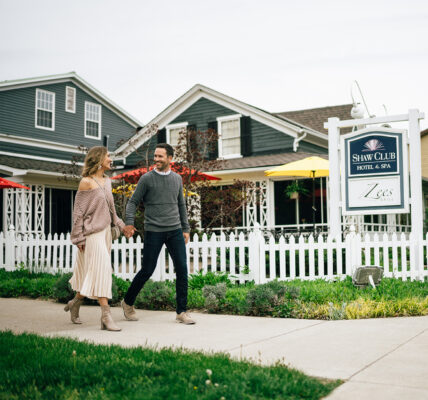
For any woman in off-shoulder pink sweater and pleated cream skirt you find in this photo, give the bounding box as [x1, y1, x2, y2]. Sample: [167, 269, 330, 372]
[64, 146, 125, 331]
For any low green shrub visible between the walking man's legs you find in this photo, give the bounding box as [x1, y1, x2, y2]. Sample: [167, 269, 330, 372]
[134, 280, 175, 310]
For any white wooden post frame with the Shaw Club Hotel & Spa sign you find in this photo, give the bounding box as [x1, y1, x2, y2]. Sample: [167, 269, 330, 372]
[324, 109, 424, 279]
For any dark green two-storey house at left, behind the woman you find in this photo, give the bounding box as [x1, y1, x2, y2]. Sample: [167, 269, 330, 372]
[0, 72, 142, 234]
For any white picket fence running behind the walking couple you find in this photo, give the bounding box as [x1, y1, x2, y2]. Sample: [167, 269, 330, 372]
[0, 229, 428, 283]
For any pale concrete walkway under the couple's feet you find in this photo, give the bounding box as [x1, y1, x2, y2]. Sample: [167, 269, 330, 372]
[0, 298, 428, 400]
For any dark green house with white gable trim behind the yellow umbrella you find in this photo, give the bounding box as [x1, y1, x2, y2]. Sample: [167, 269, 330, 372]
[115, 84, 360, 234]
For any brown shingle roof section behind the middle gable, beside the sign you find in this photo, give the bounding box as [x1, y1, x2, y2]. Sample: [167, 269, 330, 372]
[272, 104, 352, 133]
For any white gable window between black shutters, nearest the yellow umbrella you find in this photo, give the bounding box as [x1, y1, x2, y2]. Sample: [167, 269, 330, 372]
[217, 115, 241, 158]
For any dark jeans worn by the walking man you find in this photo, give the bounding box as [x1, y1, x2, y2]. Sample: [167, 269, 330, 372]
[125, 229, 187, 314]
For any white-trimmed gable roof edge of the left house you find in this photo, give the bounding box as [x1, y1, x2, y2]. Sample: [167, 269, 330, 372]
[0, 71, 143, 128]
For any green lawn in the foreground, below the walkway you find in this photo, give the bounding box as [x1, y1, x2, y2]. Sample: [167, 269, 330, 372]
[0, 332, 341, 400]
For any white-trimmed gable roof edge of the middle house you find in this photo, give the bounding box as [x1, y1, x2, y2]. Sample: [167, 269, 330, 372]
[115, 84, 327, 157]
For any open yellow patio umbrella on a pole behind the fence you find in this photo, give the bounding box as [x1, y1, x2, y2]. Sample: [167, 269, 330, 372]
[265, 156, 329, 231]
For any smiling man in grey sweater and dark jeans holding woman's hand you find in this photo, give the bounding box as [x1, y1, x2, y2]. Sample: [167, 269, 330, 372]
[122, 143, 195, 325]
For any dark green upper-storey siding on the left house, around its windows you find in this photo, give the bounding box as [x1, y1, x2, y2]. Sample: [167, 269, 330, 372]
[0, 82, 135, 150]
